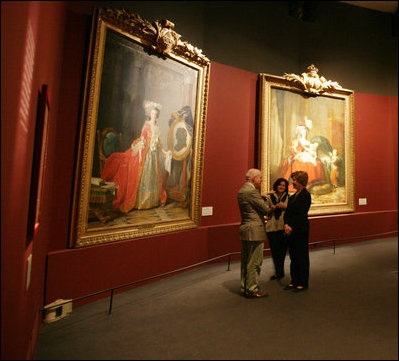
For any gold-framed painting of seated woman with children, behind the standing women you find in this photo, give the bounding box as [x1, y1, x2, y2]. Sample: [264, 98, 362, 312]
[258, 65, 355, 215]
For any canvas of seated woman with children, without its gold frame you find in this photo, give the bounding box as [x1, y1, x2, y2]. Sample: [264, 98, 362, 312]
[270, 88, 346, 204]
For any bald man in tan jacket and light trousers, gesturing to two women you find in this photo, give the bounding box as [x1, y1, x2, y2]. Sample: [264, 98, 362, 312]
[238, 168, 269, 298]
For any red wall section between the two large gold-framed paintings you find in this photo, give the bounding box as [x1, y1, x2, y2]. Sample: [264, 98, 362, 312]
[201, 62, 257, 226]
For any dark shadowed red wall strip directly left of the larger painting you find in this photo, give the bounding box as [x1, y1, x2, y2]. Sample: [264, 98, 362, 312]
[48, 2, 89, 251]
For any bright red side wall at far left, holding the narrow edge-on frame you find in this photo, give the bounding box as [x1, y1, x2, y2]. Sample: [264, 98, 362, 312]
[1, 1, 69, 359]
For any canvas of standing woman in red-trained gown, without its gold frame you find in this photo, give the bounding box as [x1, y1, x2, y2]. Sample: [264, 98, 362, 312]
[88, 31, 198, 230]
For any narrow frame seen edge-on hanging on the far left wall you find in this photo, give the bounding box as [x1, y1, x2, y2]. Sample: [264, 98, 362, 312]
[26, 84, 50, 246]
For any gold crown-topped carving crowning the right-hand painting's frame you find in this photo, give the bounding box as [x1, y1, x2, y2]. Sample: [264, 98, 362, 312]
[284, 64, 342, 95]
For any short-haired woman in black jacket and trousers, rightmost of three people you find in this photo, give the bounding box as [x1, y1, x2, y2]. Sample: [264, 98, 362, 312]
[284, 171, 312, 292]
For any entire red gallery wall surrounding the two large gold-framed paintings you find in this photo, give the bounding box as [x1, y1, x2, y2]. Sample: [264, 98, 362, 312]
[1, 1, 398, 359]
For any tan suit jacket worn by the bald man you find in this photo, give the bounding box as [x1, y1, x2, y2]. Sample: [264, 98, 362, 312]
[238, 182, 269, 241]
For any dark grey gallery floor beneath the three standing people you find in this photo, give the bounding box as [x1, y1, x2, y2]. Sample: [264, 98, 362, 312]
[35, 237, 398, 360]
